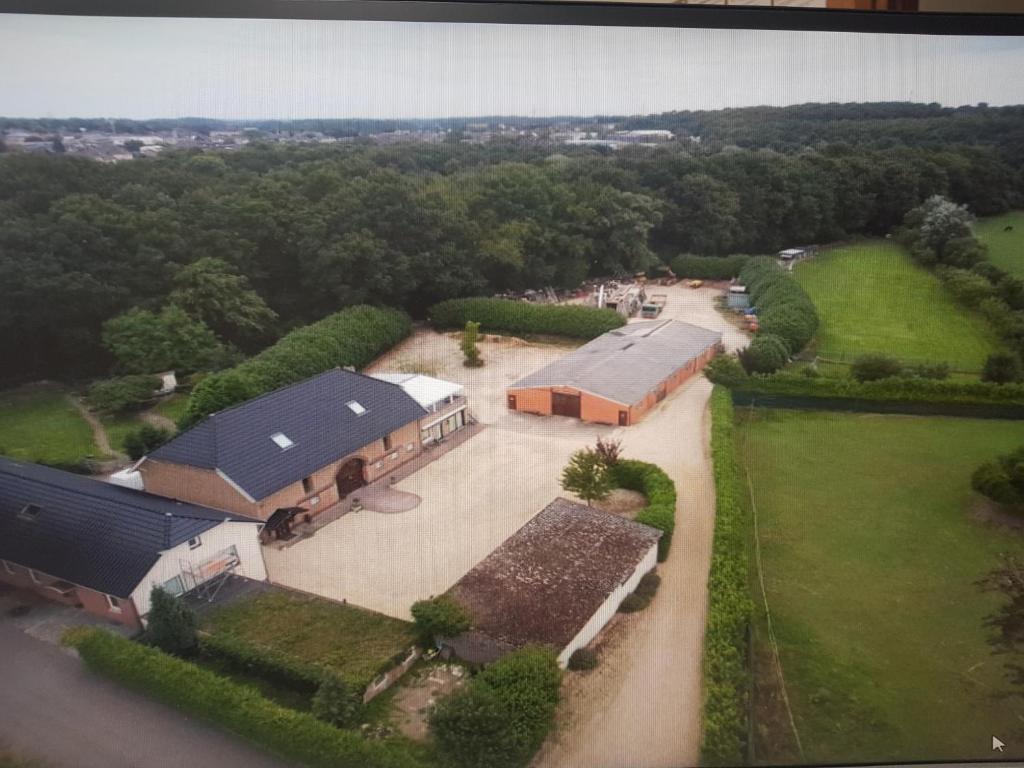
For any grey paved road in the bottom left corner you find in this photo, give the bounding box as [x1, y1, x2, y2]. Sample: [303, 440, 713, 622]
[0, 620, 286, 768]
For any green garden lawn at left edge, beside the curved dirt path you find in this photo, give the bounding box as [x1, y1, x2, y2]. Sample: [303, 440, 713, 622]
[0, 385, 98, 463]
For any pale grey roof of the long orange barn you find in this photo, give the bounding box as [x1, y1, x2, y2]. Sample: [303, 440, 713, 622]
[509, 319, 722, 406]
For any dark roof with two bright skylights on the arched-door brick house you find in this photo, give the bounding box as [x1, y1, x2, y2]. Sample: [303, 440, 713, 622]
[150, 368, 426, 501]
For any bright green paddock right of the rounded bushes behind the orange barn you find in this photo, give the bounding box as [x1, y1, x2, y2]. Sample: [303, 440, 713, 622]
[795, 241, 997, 371]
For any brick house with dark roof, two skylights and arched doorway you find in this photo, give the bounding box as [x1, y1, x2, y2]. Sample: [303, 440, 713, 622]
[137, 369, 465, 520]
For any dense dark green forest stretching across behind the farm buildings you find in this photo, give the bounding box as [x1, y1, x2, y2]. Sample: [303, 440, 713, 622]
[6, 104, 1024, 382]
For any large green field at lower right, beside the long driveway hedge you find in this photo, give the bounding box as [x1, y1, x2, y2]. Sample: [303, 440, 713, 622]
[737, 411, 1024, 763]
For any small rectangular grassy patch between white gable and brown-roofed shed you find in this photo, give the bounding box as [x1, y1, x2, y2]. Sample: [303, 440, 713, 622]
[203, 591, 415, 686]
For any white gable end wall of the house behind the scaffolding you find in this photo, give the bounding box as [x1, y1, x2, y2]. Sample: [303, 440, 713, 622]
[131, 521, 266, 616]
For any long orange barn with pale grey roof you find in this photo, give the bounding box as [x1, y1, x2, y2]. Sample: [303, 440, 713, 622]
[506, 319, 722, 427]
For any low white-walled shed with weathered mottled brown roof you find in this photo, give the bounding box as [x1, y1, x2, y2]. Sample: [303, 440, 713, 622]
[440, 499, 662, 667]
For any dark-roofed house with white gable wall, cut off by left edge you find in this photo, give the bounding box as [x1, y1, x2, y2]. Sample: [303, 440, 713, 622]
[0, 458, 266, 629]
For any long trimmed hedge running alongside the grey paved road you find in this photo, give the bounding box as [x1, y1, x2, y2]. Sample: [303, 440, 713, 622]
[67, 629, 424, 768]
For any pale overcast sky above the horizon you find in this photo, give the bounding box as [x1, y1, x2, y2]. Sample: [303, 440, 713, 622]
[0, 14, 1024, 119]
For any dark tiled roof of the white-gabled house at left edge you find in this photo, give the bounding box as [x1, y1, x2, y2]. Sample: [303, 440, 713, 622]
[0, 457, 260, 597]
